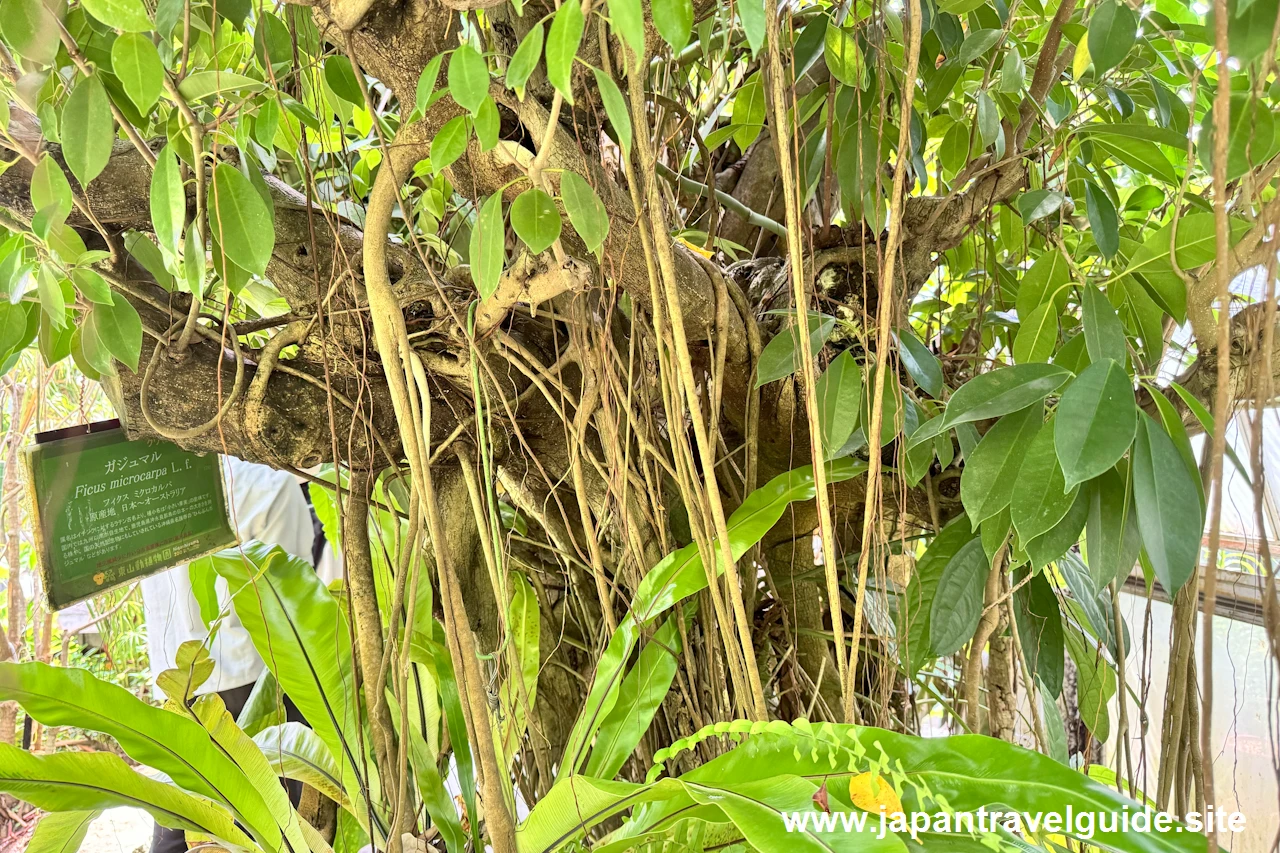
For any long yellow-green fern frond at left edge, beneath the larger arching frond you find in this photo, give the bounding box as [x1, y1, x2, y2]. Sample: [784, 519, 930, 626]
[0, 742, 253, 849]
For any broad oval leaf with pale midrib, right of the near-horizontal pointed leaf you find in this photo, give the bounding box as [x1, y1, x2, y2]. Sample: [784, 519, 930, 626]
[1053, 359, 1138, 488]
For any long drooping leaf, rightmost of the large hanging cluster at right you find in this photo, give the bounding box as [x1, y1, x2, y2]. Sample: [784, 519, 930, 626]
[1133, 412, 1204, 596]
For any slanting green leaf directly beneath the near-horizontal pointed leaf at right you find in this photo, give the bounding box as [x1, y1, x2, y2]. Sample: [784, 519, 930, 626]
[960, 403, 1044, 530]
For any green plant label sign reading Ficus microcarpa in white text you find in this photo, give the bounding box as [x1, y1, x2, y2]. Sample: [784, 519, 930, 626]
[24, 421, 237, 610]
